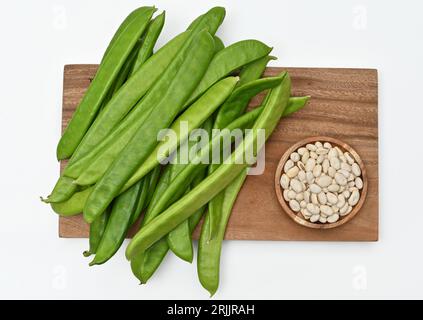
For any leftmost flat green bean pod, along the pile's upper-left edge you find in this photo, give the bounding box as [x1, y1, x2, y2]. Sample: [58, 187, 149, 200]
[57, 7, 156, 160]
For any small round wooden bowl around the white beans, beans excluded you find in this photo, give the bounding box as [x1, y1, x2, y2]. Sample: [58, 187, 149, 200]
[275, 136, 368, 229]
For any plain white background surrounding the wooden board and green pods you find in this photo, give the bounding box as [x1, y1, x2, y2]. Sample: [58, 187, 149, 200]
[0, 0, 423, 299]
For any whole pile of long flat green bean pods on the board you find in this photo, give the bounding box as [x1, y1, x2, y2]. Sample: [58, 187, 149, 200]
[42, 7, 309, 295]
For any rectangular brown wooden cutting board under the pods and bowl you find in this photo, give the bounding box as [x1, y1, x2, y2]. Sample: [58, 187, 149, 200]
[59, 65, 379, 241]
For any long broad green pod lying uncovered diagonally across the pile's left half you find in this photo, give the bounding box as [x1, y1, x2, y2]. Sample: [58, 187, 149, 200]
[84, 31, 214, 222]
